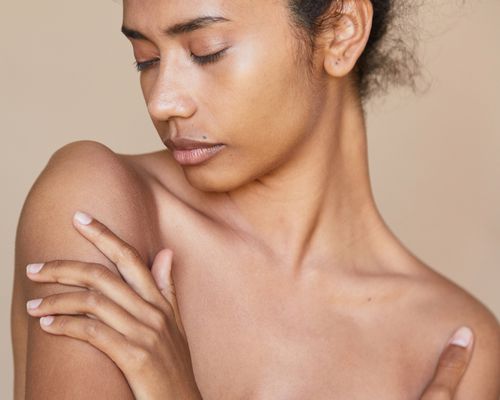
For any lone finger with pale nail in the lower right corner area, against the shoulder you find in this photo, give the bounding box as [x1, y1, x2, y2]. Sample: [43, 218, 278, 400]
[420, 327, 473, 400]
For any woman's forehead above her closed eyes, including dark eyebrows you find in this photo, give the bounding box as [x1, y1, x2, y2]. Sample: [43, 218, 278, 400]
[122, 0, 294, 48]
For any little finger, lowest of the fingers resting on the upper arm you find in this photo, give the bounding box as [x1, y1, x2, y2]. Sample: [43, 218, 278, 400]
[40, 315, 141, 373]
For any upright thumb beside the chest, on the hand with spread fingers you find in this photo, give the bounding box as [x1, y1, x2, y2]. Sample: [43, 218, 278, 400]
[151, 249, 186, 338]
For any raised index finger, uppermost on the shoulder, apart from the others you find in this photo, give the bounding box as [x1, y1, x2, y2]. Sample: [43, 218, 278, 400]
[73, 211, 163, 305]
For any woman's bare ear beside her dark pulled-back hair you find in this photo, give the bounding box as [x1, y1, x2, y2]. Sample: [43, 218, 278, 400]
[324, 0, 373, 78]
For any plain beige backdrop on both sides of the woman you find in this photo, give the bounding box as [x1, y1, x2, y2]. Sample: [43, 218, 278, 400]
[0, 0, 500, 399]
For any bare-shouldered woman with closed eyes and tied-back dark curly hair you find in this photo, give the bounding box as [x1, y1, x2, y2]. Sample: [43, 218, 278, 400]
[12, 0, 500, 400]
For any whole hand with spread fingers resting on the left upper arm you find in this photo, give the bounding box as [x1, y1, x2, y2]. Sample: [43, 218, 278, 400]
[27, 213, 201, 400]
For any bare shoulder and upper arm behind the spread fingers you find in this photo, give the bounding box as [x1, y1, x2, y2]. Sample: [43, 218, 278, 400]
[12, 141, 155, 400]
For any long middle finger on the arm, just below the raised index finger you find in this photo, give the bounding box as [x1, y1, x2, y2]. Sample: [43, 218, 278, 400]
[26, 260, 168, 326]
